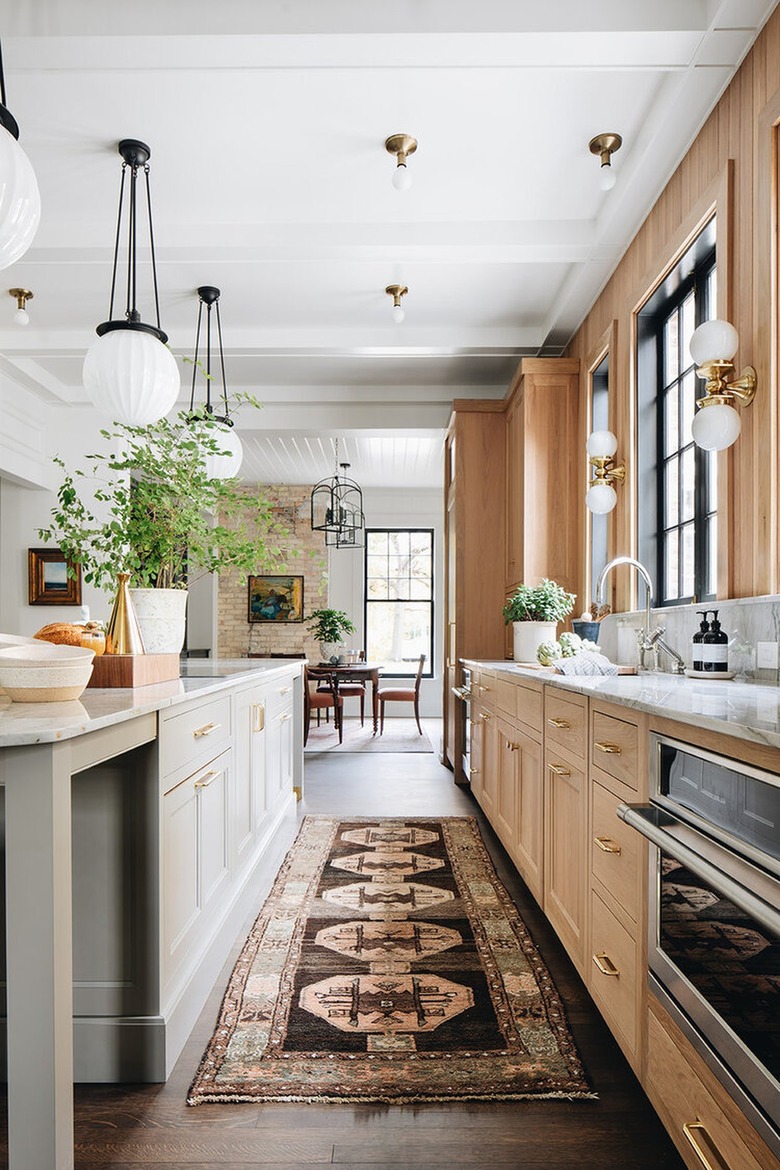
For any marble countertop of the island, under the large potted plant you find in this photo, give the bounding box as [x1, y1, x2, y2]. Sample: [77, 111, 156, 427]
[0, 659, 303, 748]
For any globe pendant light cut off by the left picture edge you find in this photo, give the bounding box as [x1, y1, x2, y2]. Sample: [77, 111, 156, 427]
[0, 41, 41, 268]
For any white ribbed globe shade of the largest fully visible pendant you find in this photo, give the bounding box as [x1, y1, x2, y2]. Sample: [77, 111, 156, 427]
[83, 329, 181, 427]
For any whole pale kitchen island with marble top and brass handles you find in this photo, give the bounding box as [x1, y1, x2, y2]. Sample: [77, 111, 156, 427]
[0, 660, 303, 1170]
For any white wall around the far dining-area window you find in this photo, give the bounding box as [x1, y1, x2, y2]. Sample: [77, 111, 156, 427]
[327, 488, 444, 718]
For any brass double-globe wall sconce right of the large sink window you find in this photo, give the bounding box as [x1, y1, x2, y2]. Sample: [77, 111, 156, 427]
[690, 321, 757, 450]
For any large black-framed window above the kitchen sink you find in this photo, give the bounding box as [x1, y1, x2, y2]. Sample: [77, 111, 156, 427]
[637, 220, 718, 606]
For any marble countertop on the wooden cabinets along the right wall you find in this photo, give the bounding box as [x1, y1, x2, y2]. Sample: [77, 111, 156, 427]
[463, 659, 780, 748]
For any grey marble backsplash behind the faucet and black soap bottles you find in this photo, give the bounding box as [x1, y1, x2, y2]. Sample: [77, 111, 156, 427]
[591, 594, 780, 684]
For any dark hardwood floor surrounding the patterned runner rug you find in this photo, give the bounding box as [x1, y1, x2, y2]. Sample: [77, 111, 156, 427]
[67, 724, 684, 1170]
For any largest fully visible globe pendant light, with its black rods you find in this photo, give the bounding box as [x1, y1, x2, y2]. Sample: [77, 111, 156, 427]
[83, 138, 180, 427]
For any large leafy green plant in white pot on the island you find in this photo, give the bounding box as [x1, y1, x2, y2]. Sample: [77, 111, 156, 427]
[39, 411, 285, 653]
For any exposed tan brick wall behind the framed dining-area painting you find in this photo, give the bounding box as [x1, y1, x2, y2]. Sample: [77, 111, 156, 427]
[214, 484, 327, 662]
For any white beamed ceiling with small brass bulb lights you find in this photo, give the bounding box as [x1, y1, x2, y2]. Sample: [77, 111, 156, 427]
[0, 0, 775, 487]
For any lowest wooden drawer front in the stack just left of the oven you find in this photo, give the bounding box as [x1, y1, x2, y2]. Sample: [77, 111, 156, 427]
[589, 893, 639, 1052]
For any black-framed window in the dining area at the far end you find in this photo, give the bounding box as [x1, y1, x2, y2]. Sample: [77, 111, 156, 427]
[365, 528, 434, 677]
